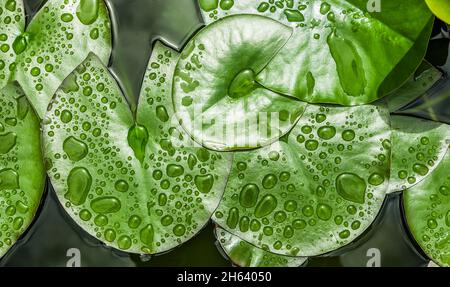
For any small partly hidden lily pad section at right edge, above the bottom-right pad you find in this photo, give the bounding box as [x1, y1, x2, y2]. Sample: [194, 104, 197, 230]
[389, 116, 450, 192]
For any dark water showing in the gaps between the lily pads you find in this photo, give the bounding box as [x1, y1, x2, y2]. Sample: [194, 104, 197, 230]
[0, 0, 445, 266]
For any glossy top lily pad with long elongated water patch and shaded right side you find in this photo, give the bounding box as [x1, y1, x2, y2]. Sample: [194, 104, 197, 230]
[199, 0, 433, 105]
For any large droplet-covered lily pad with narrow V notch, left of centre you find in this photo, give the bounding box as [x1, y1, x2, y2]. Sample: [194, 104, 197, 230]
[44, 43, 231, 254]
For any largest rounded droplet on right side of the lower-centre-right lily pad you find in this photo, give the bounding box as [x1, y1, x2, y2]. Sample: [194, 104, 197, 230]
[336, 173, 367, 204]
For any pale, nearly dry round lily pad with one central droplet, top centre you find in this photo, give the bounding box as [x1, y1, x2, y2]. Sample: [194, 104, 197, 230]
[173, 15, 306, 151]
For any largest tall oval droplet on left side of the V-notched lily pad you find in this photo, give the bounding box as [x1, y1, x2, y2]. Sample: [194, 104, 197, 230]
[64, 167, 92, 206]
